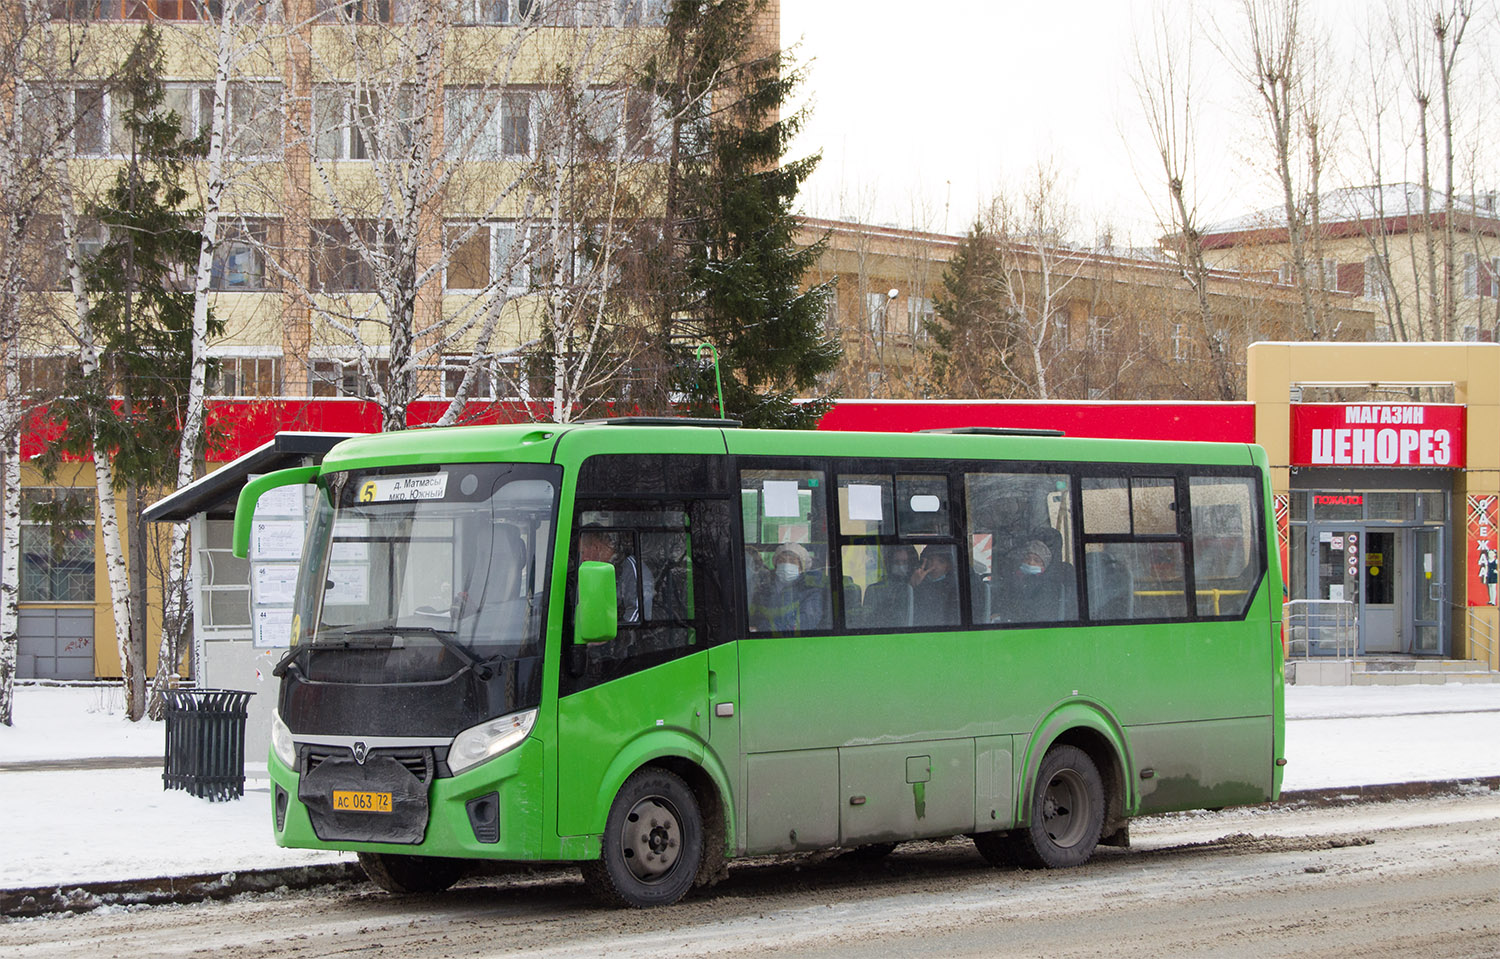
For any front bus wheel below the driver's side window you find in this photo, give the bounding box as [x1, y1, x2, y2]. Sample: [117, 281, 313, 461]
[582, 765, 704, 909]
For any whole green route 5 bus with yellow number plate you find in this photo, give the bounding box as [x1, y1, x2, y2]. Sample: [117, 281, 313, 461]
[236, 419, 1284, 906]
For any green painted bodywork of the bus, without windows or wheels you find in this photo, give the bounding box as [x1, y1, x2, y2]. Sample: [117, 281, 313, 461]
[272, 423, 1286, 858]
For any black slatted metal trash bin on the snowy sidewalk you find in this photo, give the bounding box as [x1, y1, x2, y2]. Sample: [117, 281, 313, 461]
[162, 689, 255, 803]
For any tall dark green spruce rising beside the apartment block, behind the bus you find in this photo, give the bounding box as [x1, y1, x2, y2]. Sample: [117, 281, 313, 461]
[647, 0, 840, 428]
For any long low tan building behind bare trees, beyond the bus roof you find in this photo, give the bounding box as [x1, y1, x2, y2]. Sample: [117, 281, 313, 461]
[798, 218, 1377, 399]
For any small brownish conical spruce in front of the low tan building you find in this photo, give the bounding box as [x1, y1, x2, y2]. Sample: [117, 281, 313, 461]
[927, 219, 1022, 399]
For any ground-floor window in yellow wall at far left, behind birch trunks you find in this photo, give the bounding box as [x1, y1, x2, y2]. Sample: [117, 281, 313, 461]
[20, 488, 95, 603]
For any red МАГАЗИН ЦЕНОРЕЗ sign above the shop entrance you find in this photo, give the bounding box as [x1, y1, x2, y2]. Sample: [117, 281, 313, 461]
[1292, 402, 1464, 468]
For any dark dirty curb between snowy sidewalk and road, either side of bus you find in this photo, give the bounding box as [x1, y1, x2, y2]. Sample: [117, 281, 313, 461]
[0, 776, 1500, 918]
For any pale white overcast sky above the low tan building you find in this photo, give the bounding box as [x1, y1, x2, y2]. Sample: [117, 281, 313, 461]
[782, 0, 1440, 245]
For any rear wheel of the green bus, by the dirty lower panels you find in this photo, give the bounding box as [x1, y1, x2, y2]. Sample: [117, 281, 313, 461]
[1014, 746, 1104, 869]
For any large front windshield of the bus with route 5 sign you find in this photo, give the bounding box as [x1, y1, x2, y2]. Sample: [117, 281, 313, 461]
[297, 464, 557, 683]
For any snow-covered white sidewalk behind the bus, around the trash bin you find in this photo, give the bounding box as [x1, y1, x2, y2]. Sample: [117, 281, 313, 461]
[0, 684, 1500, 888]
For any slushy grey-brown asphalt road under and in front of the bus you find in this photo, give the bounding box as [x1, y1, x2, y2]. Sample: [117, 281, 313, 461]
[0, 786, 1500, 959]
